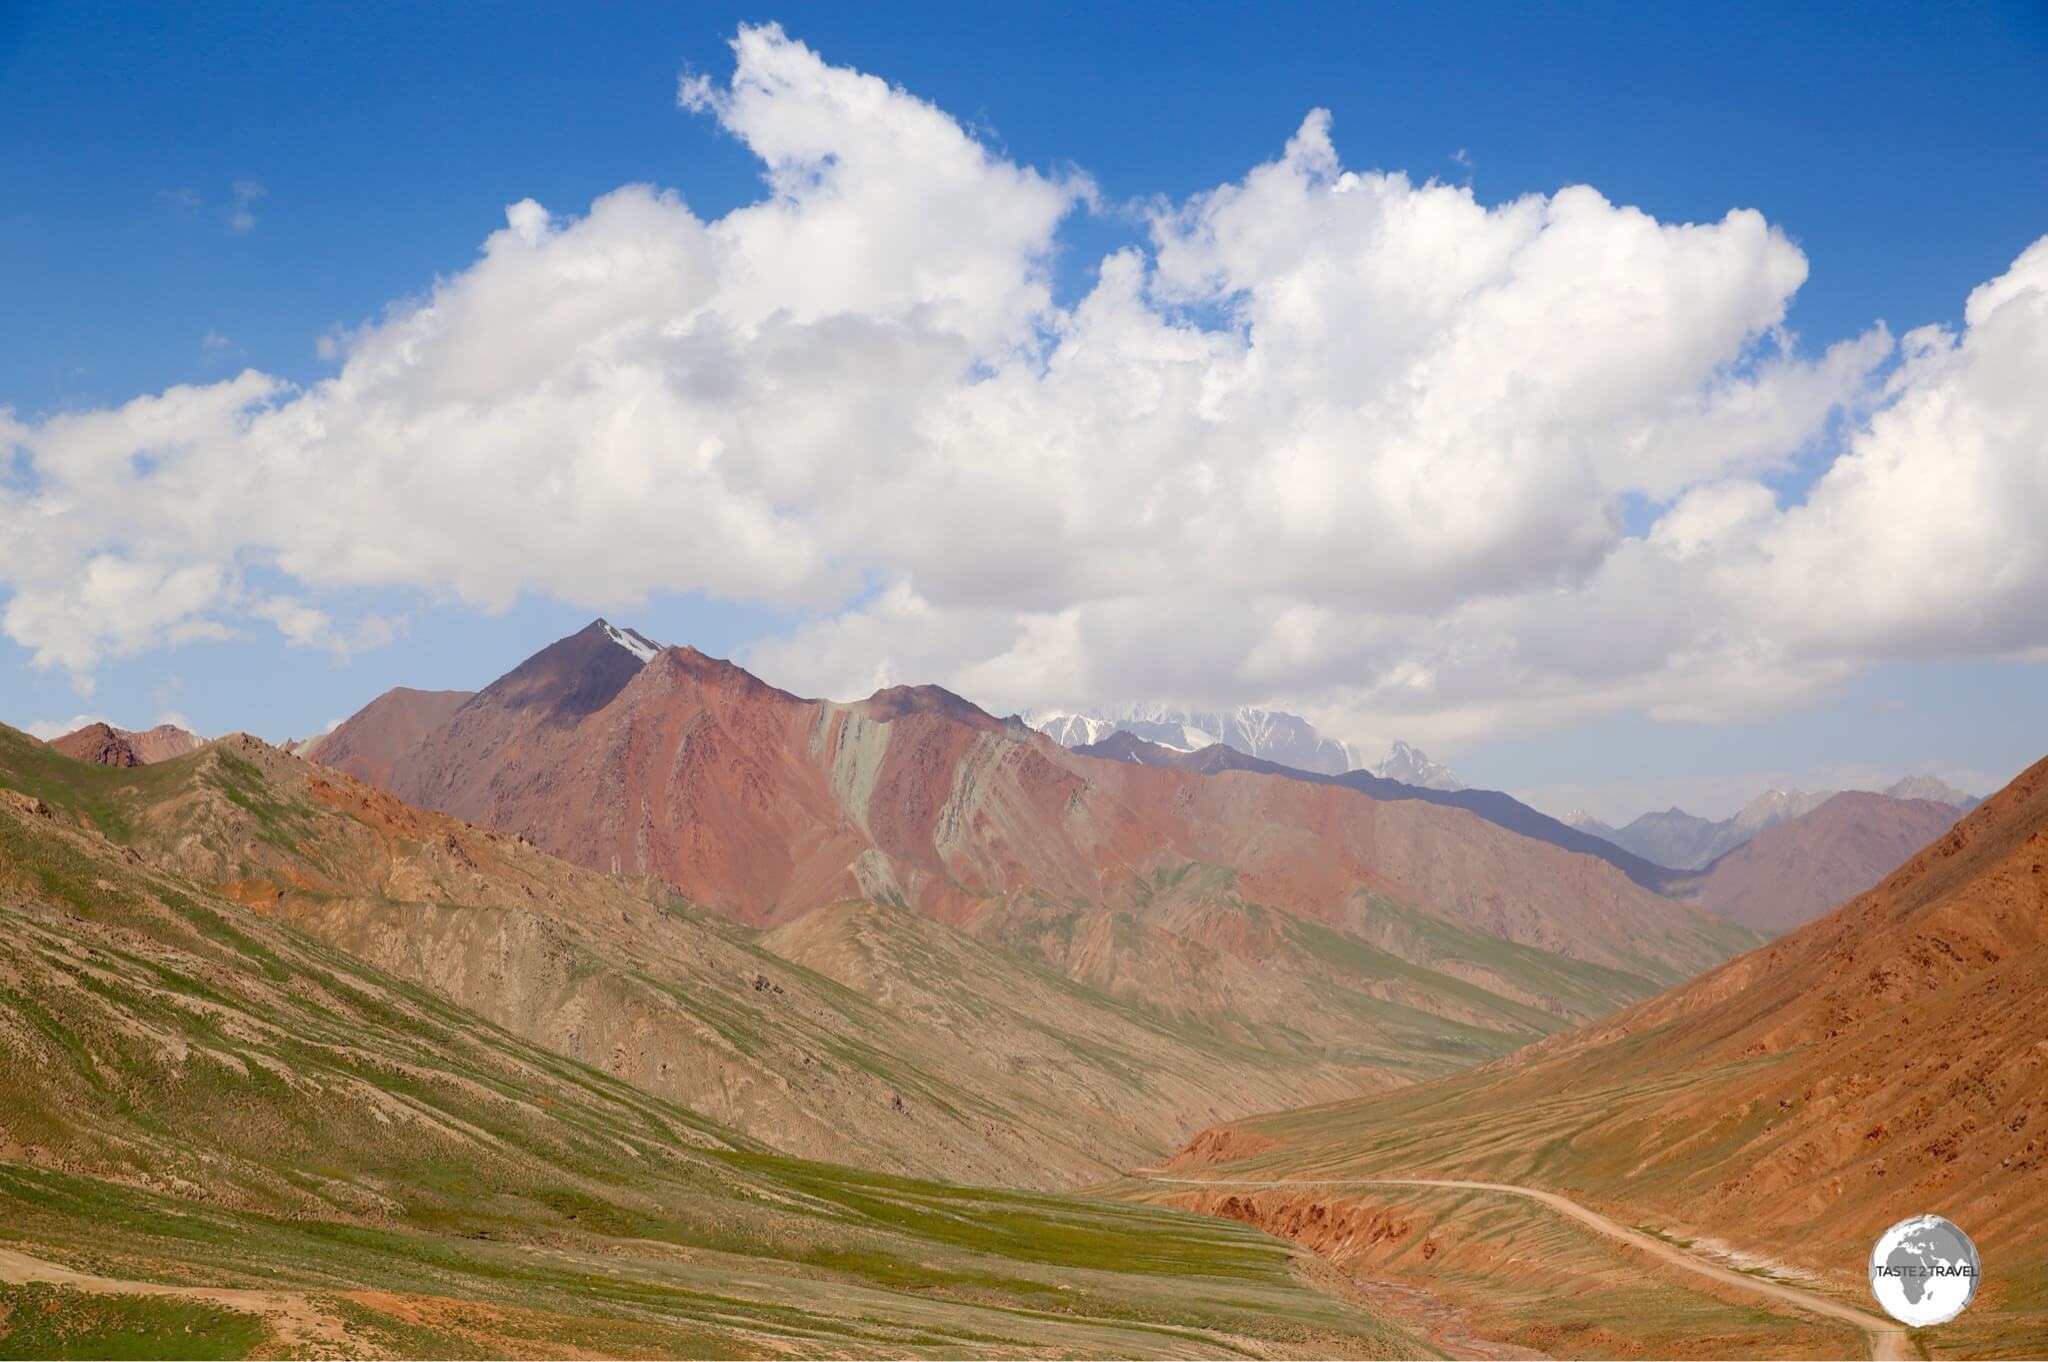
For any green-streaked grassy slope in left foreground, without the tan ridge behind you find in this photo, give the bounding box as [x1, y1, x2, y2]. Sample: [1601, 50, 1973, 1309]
[0, 729, 1415, 1356]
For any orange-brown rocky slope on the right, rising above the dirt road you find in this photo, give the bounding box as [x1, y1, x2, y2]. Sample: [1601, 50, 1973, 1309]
[1184, 760, 2048, 1356]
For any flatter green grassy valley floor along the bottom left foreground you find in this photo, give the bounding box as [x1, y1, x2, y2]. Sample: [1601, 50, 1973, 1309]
[0, 1159, 1427, 1358]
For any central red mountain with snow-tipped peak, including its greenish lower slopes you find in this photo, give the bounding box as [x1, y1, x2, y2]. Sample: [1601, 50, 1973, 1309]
[296, 621, 1755, 1114]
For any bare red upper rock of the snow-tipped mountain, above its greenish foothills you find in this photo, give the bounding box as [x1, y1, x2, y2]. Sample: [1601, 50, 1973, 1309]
[322, 621, 1741, 983]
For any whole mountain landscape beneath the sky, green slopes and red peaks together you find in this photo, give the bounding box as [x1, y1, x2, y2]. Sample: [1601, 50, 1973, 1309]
[0, 621, 2048, 1356]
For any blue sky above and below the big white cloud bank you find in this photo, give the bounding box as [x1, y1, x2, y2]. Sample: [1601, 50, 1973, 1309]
[0, 2, 2048, 811]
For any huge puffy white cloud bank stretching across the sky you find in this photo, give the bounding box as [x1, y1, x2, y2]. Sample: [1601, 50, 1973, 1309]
[0, 27, 2048, 741]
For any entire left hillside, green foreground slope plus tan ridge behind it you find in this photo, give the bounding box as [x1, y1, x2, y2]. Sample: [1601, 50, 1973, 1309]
[0, 727, 1419, 1358]
